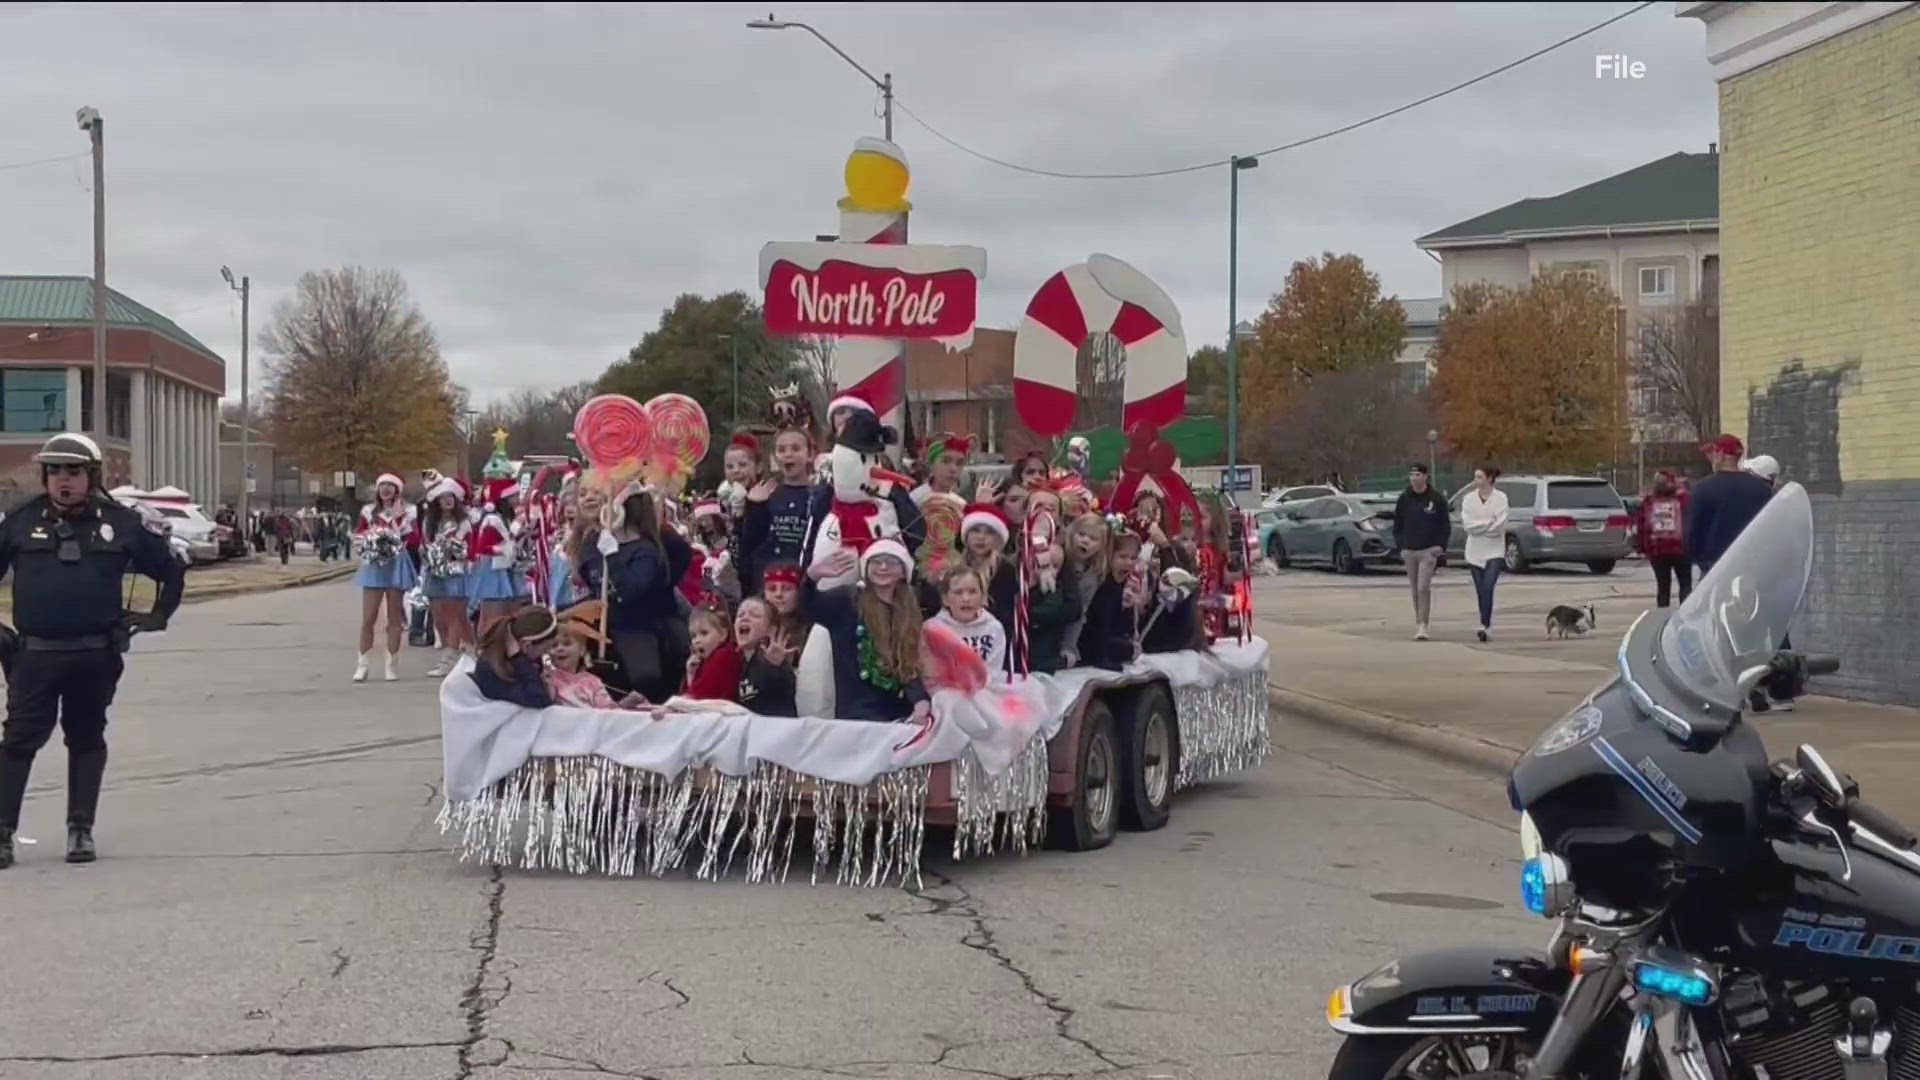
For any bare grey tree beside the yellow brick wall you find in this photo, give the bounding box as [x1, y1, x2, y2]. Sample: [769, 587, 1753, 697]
[1632, 294, 1720, 442]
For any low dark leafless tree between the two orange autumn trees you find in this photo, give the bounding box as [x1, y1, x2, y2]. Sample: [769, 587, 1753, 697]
[1246, 361, 1432, 488]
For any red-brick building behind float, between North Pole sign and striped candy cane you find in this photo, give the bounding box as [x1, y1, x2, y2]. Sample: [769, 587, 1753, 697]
[906, 329, 1046, 459]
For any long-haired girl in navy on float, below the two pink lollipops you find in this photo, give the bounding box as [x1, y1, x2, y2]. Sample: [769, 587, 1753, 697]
[580, 482, 693, 701]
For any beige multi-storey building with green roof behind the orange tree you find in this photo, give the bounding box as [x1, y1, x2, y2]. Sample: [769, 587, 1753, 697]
[1402, 146, 1720, 442]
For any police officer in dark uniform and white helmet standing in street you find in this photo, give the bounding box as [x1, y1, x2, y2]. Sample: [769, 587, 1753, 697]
[0, 432, 186, 869]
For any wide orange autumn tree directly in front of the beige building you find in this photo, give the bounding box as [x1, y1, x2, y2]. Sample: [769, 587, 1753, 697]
[1428, 273, 1626, 469]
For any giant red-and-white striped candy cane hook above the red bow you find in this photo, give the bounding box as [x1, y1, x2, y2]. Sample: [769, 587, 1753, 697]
[1014, 256, 1187, 438]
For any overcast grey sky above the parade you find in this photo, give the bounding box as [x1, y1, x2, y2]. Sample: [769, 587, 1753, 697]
[0, 4, 1716, 398]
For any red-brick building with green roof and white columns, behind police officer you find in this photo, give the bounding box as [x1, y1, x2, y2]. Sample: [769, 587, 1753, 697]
[0, 277, 227, 498]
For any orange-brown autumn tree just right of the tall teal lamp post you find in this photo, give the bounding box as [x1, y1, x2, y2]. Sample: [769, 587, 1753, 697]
[1240, 252, 1407, 415]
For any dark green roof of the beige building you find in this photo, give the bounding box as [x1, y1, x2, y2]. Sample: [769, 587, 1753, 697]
[1415, 154, 1720, 248]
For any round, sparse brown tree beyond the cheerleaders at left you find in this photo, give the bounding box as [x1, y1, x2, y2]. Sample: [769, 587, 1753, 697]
[259, 267, 459, 477]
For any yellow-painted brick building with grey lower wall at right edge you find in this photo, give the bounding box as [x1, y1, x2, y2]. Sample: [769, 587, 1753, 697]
[1678, 2, 1920, 703]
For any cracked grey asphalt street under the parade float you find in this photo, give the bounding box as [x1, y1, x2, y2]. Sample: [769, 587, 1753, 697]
[0, 573, 1528, 1080]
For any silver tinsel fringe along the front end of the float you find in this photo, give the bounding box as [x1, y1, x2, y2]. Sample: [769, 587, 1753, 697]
[438, 751, 944, 888]
